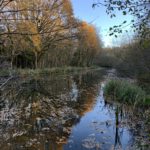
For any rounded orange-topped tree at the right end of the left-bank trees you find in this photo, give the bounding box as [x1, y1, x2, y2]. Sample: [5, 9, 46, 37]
[73, 21, 102, 66]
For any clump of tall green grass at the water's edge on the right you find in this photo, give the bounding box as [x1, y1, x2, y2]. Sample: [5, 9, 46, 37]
[104, 80, 150, 105]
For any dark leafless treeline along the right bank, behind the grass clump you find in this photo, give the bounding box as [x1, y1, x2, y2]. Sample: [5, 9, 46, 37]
[97, 39, 150, 89]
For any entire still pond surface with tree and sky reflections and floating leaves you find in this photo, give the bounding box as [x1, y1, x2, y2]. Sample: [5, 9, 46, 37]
[0, 70, 148, 150]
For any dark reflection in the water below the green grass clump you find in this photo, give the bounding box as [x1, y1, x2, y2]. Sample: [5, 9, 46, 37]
[104, 100, 149, 150]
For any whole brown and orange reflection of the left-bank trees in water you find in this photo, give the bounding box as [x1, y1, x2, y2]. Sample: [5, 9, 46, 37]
[0, 70, 104, 150]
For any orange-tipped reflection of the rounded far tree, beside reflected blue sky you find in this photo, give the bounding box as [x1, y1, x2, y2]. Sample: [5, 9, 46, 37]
[72, 71, 104, 116]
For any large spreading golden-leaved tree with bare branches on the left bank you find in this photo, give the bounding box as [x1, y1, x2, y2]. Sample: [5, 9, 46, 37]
[0, 0, 76, 68]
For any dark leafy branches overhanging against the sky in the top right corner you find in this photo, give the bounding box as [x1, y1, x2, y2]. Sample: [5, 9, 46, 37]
[93, 0, 150, 38]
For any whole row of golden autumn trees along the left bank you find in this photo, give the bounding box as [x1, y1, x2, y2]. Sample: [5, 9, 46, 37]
[0, 0, 102, 68]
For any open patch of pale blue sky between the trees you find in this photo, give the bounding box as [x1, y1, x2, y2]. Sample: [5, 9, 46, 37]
[71, 0, 132, 47]
